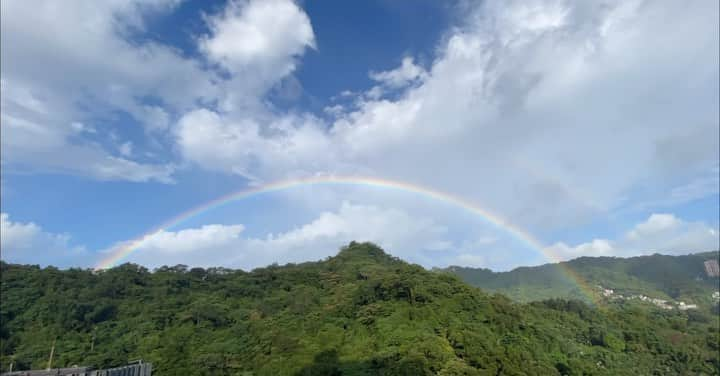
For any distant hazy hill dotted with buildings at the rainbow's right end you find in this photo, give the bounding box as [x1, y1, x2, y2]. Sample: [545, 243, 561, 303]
[440, 252, 719, 307]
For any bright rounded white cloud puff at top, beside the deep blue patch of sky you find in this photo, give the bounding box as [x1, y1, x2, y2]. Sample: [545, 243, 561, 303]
[200, 0, 315, 111]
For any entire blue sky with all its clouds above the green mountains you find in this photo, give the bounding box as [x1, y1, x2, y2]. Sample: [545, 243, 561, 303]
[0, 0, 720, 270]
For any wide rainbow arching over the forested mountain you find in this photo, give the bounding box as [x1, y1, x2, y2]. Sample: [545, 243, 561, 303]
[95, 176, 595, 301]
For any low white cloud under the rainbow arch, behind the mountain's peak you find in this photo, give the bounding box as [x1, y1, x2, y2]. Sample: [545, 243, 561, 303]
[110, 202, 451, 269]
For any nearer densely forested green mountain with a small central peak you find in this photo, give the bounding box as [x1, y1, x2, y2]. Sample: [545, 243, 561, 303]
[0, 243, 720, 375]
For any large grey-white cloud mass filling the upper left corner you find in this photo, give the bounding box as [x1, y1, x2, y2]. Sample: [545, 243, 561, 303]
[1, 0, 214, 182]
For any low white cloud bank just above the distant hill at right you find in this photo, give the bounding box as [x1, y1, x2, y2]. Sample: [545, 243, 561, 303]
[546, 214, 720, 260]
